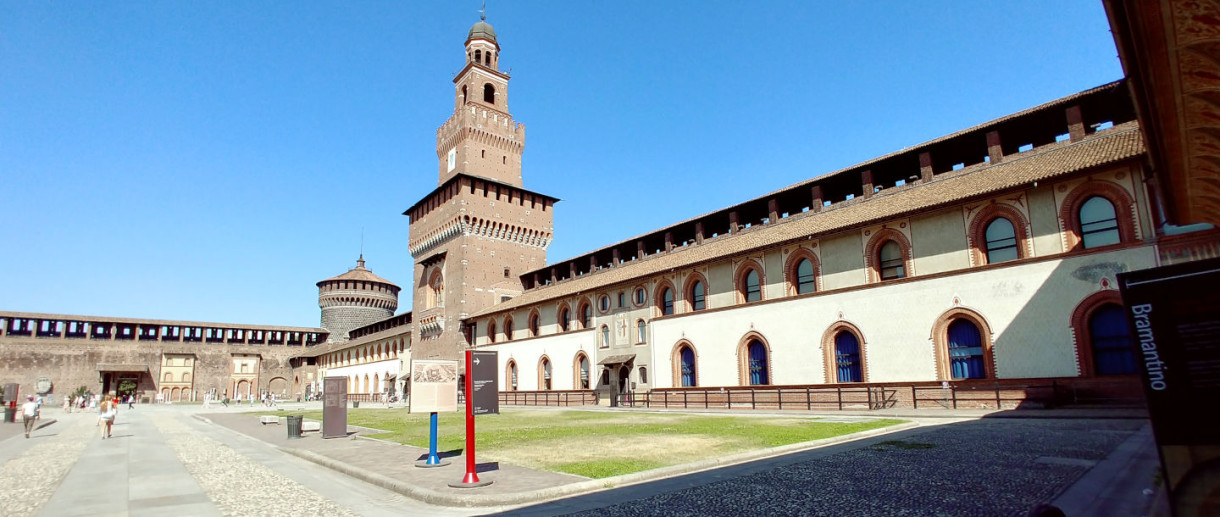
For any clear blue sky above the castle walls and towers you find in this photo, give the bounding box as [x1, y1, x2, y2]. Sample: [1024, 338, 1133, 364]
[0, 0, 1122, 327]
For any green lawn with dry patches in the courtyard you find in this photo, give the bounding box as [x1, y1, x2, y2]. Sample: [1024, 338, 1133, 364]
[269, 408, 903, 478]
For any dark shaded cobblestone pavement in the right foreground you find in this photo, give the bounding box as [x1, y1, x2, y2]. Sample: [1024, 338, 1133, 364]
[510, 419, 1144, 517]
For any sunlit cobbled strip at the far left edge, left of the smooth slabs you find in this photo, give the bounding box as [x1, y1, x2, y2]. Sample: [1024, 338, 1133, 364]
[0, 421, 98, 517]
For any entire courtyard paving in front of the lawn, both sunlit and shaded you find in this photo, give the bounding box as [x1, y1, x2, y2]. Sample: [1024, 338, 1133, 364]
[0, 406, 1165, 517]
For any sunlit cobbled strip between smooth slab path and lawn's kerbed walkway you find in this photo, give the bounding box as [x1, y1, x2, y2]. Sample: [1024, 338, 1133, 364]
[151, 415, 355, 516]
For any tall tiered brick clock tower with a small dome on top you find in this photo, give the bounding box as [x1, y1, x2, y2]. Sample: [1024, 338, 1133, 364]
[403, 21, 559, 358]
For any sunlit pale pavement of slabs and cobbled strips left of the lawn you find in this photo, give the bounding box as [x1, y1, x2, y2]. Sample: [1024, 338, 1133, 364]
[0, 406, 477, 517]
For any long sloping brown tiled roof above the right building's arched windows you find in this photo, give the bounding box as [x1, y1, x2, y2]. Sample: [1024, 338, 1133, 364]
[466, 122, 1144, 319]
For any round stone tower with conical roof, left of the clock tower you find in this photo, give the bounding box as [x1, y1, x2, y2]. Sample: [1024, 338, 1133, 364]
[317, 255, 399, 343]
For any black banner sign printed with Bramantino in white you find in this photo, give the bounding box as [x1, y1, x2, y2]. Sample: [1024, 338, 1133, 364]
[1118, 259, 1220, 516]
